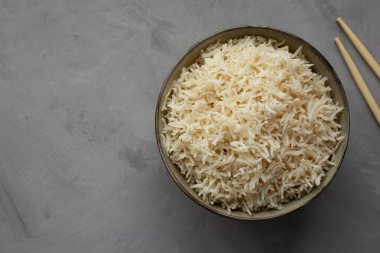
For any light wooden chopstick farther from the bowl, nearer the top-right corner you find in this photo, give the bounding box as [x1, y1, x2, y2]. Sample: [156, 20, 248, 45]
[336, 17, 380, 78]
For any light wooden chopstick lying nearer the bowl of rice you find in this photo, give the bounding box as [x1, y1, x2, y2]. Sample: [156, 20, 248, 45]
[335, 37, 380, 125]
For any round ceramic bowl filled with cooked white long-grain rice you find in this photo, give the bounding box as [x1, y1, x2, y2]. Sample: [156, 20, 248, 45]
[155, 26, 349, 220]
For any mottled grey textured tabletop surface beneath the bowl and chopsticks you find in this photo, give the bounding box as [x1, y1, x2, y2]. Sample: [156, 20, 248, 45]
[0, 0, 380, 253]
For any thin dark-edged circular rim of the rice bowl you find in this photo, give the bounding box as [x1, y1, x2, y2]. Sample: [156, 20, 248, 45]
[155, 25, 350, 221]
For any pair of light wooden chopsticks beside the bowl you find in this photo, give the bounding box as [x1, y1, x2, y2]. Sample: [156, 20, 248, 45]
[335, 17, 380, 125]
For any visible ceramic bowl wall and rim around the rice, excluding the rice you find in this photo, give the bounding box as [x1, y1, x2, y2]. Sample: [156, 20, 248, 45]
[155, 26, 349, 220]
